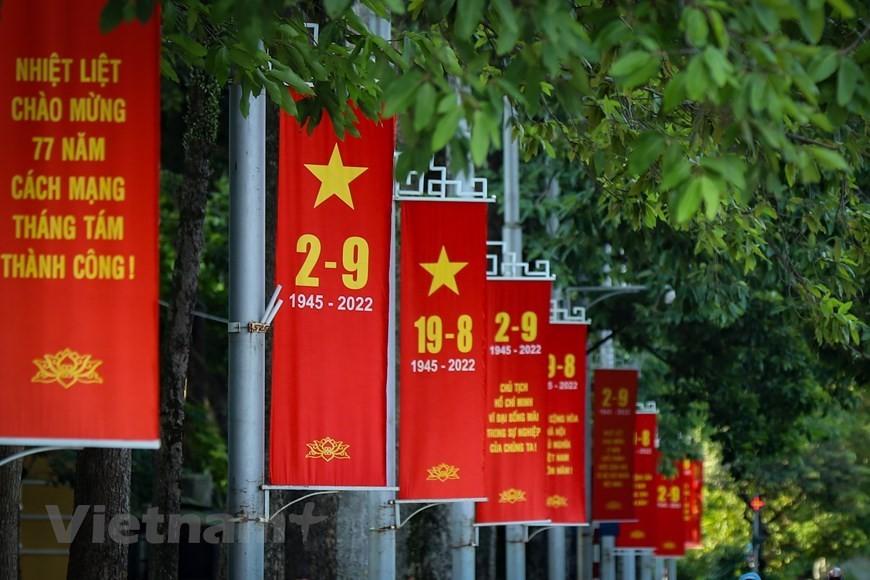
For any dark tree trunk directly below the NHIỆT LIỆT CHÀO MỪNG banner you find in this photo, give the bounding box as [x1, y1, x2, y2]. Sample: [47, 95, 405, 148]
[66, 449, 136, 580]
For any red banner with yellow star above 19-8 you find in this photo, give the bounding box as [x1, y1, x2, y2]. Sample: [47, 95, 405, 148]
[399, 201, 487, 499]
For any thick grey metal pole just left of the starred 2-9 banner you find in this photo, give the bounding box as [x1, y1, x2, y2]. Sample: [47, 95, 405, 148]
[228, 80, 266, 580]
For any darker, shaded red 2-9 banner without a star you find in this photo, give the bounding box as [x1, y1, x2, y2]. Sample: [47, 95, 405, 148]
[592, 369, 638, 522]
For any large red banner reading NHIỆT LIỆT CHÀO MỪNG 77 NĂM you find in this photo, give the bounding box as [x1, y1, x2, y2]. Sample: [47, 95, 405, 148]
[0, 0, 160, 447]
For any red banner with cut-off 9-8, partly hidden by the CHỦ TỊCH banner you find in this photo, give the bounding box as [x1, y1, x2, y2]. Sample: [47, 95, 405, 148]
[545, 321, 589, 524]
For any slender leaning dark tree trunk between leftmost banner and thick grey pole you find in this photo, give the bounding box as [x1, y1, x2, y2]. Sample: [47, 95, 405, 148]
[148, 69, 220, 580]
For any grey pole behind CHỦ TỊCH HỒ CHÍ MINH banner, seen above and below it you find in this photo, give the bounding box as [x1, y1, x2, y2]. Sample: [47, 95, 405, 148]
[502, 94, 526, 580]
